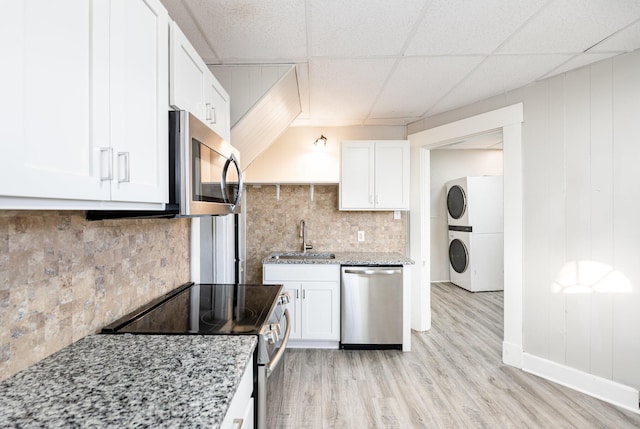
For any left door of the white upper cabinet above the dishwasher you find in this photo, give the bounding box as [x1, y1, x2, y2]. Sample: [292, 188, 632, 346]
[340, 141, 375, 210]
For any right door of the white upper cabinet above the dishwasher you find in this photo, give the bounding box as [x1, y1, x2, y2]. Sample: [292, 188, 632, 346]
[374, 141, 409, 210]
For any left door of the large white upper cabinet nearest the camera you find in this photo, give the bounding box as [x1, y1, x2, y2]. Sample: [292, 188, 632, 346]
[0, 0, 110, 200]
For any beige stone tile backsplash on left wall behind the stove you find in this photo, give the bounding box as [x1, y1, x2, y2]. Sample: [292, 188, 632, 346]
[0, 210, 190, 379]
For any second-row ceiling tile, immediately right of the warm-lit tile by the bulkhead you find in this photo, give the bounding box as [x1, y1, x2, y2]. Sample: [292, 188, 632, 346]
[371, 56, 484, 118]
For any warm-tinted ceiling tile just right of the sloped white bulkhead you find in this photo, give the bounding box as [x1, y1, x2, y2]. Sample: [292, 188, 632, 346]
[309, 59, 395, 120]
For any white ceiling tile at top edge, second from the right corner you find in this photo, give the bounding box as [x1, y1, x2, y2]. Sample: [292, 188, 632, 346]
[406, 0, 548, 55]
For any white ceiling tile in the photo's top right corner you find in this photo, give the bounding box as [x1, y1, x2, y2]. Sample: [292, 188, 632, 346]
[499, 0, 640, 53]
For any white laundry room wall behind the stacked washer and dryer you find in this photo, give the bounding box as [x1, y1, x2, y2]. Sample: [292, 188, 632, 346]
[430, 149, 502, 281]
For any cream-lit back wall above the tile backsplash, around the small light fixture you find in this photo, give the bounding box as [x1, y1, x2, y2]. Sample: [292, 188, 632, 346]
[245, 126, 407, 183]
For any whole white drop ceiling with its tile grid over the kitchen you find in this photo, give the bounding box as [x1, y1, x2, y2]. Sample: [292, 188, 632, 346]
[161, 0, 640, 126]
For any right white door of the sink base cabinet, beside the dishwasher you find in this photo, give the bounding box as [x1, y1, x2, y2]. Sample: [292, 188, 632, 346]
[301, 282, 340, 341]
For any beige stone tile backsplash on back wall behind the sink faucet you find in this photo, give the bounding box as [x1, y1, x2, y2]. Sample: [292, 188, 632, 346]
[245, 185, 407, 283]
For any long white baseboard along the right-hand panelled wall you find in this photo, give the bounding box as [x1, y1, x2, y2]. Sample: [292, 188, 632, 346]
[524, 352, 640, 414]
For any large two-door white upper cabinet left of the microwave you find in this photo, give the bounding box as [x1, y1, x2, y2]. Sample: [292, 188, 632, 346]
[0, 0, 168, 209]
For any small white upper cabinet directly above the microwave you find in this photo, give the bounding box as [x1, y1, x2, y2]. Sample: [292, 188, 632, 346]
[169, 22, 231, 141]
